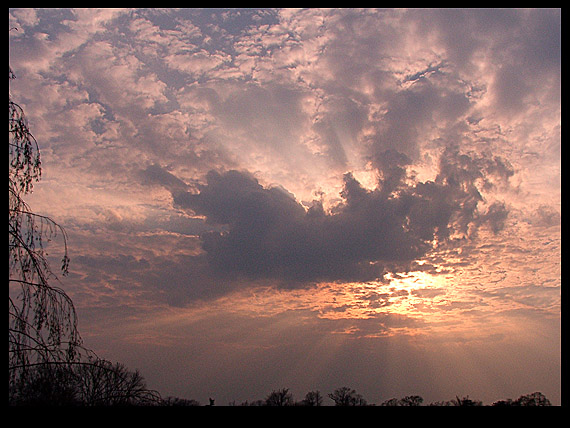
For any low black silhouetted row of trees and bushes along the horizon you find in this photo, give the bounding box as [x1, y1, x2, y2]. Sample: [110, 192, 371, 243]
[9, 372, 551, 407]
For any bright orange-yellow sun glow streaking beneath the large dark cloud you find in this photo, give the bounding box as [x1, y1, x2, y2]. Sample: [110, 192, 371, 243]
[205, 264, 458, 326]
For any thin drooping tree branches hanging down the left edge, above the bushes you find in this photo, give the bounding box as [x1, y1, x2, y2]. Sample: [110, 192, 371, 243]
[8, 64, 81, 402]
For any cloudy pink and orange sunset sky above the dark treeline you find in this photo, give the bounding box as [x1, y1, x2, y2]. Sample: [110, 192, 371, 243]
[9, 8, 561, 405]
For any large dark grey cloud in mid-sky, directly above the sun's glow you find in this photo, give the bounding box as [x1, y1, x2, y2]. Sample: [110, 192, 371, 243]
[169, 154, 506, 294]
